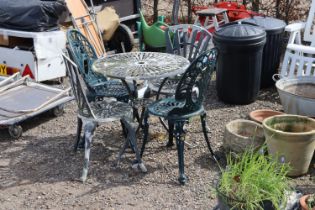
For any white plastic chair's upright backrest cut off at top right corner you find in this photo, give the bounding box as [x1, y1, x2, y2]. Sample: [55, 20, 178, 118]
[304, 0, 315, 46]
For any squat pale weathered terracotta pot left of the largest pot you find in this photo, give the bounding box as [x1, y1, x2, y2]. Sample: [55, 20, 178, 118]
[223, 119, 265, 152]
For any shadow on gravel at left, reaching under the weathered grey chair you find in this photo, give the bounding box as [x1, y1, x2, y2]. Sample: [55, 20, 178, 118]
[0, 130, 155, 189]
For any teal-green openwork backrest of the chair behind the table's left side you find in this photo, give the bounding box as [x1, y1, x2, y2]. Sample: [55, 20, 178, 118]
[67, 29, 107, 86]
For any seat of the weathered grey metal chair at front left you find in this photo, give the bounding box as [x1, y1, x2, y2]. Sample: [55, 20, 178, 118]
[80, 99, 132, 122]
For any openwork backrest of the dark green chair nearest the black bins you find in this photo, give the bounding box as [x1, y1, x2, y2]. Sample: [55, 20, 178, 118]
[175, 48, 218, 113]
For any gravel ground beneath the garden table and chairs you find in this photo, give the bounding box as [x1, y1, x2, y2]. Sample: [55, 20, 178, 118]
[0, 80, 315, 210]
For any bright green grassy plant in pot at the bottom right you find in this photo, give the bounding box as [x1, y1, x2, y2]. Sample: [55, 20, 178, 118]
[217, 150, 290, 210]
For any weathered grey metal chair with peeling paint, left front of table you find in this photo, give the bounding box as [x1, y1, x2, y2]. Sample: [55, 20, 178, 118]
[63, 55, 147, 182]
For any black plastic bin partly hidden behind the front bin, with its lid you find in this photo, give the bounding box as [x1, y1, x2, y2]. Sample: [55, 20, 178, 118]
[242, 16, 286, 88]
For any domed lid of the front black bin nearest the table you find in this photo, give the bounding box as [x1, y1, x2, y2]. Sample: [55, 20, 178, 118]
[213, 22, 266, 45]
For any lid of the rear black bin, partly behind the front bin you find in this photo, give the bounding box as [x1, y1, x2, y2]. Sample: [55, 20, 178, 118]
[242, 16, 286, 33]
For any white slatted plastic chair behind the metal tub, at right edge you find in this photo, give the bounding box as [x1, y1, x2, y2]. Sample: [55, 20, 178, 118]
[280, 0, 315, 78]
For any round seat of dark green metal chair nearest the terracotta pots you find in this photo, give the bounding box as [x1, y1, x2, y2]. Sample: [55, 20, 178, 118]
[148, 97, 204, 120]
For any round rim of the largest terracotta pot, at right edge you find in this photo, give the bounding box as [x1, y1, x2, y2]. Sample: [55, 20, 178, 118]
[262, 114, 315, 136]
